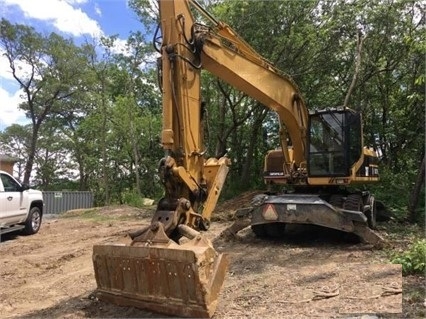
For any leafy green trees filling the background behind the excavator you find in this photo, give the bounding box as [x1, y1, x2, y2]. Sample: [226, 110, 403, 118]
[0, 0, 426, 219]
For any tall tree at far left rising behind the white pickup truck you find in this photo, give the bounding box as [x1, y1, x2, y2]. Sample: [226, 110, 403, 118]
[0, 18, 93, 183]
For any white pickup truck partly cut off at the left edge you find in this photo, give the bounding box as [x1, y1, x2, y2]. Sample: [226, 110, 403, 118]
[0, 170, 44, 235]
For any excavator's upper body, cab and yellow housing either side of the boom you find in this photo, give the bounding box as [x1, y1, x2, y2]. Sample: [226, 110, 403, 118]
[264, 108, 379, 185]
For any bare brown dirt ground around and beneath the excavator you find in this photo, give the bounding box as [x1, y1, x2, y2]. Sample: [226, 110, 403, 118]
[0, 199, 426, 319]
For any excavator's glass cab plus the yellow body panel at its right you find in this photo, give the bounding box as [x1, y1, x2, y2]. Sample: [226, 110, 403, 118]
[307, 108, 379, 184]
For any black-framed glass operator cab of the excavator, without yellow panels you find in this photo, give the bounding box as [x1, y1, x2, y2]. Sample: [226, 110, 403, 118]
[308, 109, 362, 177]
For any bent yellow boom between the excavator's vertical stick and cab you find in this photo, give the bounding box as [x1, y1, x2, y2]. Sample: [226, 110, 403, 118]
[195, 23, 308, 175]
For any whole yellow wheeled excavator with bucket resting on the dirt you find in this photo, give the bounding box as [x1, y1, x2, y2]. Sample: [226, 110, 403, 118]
[93, 0, 381, 317]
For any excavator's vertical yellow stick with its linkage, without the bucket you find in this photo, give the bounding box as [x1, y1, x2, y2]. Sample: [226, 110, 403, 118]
[154, 1, 235, 235]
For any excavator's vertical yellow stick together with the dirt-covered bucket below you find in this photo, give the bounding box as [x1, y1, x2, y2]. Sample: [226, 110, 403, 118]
[93, 0, 238, 317]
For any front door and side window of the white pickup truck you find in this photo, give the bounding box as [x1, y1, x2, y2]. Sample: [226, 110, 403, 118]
[0, 172, 26, 226]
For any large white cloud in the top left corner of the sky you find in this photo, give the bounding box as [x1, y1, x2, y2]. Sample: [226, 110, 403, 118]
[0, 0, 103, 37]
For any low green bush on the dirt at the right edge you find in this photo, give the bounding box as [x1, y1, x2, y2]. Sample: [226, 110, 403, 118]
[391, 239, 426, 275]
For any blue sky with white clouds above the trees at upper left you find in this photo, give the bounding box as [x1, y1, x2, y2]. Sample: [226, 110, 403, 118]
[0, 0, 142, 131]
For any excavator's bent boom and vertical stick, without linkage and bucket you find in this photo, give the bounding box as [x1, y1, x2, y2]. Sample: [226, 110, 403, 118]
[159, 0, 308, 192]
